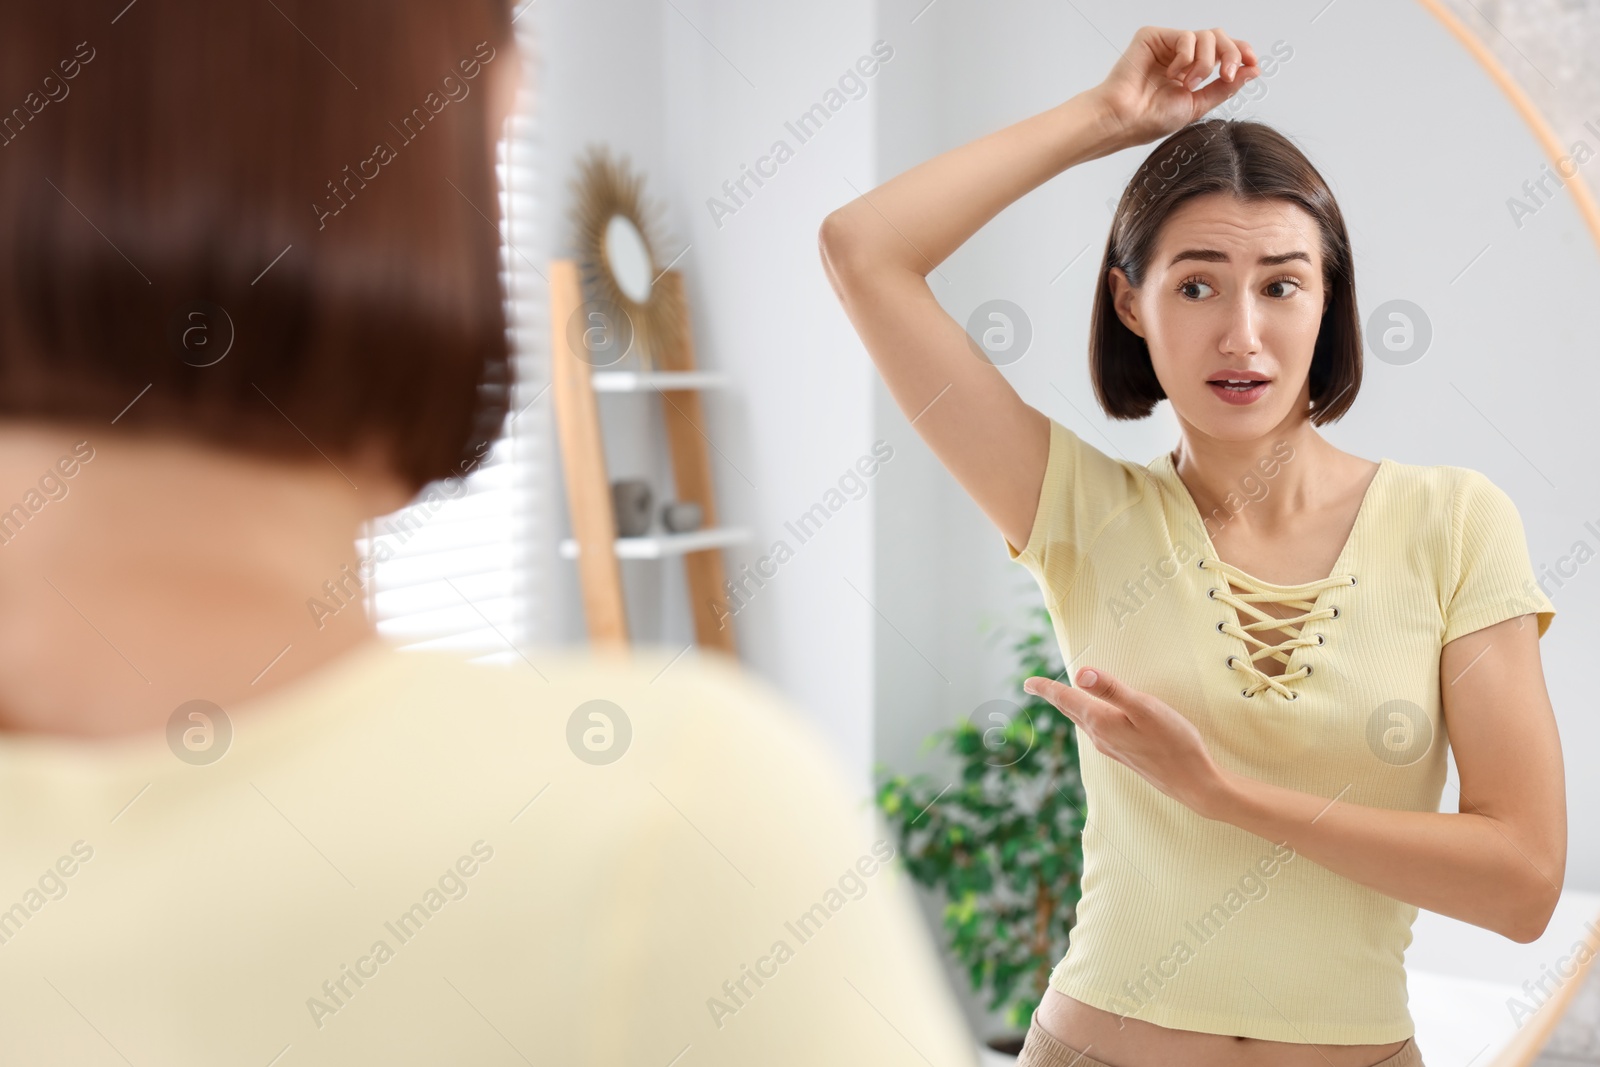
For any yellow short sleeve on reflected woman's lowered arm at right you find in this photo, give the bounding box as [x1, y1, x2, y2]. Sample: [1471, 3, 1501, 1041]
[1442, 469, 1555, 645]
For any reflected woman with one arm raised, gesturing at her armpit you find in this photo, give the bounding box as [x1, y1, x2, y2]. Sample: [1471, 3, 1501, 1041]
[819, 27, 1566, 1067]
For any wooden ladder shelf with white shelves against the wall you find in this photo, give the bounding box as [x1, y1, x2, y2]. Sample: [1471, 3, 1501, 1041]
[550, 259, 732, 656]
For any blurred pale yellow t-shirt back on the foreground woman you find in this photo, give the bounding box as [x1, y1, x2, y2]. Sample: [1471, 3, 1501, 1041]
[0, 640, 978, 1067]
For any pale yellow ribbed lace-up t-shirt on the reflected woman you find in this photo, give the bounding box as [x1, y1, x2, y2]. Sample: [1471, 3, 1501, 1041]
[1006, 419, 1555, 1045]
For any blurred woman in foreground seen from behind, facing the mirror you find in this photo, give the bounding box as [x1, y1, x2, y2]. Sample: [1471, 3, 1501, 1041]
[0, 0, 974, 1067]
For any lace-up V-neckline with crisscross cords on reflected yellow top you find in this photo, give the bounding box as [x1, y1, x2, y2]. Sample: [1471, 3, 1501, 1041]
[1154, 451, 1392, 701]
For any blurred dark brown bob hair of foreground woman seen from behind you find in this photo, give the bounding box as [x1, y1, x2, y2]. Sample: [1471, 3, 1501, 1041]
[0, 0, 517, 490]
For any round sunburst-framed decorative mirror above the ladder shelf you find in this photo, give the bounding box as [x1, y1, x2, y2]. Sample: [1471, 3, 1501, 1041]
[571, 144, 686, 370]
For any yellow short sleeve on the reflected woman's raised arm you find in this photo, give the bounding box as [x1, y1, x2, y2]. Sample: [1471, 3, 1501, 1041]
[1005, 419, 1147, 598]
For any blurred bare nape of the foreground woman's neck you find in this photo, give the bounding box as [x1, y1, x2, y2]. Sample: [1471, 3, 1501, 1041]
[0, 422, 406, 737]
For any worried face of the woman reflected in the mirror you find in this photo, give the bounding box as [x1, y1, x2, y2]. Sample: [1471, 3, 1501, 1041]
[1112, 194, 1326, 442]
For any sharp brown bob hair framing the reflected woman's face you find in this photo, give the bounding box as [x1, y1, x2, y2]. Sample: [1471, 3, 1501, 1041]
[1090, 118, 1362, 426]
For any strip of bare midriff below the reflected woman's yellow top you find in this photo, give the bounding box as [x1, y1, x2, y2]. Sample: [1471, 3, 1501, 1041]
[1035, 989, 1405, 1067]
